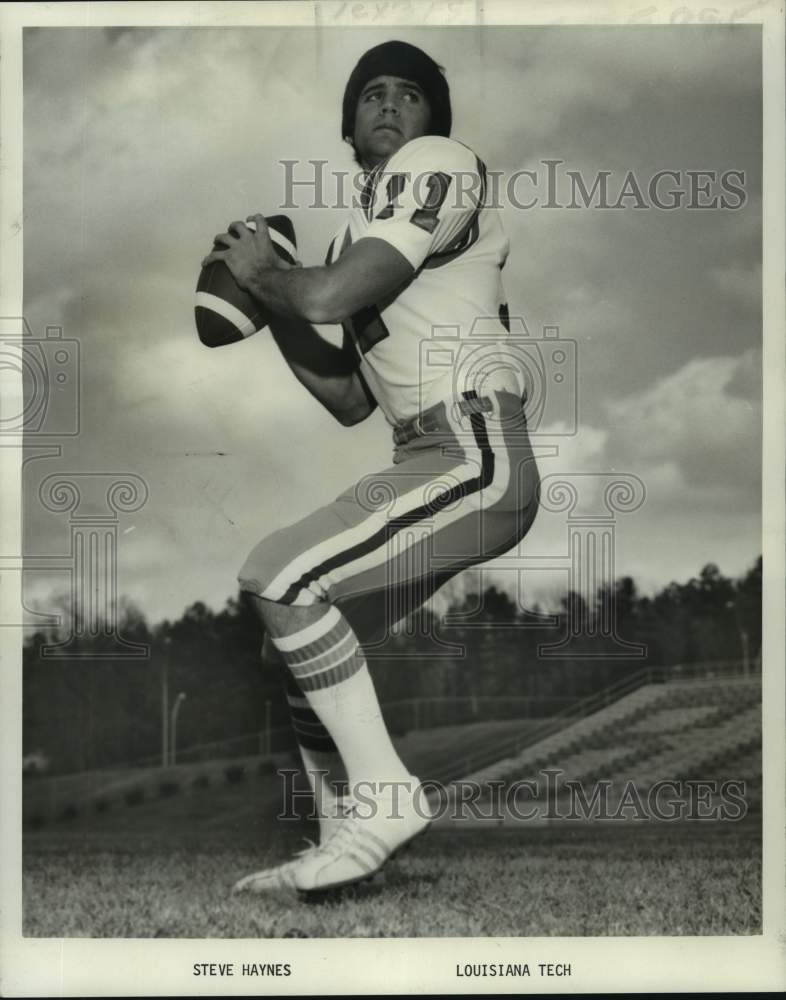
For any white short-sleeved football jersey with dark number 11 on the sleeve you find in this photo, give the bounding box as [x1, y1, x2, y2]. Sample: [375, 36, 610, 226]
[327, 136, 519, 424]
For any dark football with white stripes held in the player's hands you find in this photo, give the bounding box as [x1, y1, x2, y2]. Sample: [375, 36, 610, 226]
[194, 215, 297, 347]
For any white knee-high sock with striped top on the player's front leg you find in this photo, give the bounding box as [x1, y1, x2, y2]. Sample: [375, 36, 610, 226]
[272, 607, 409, 791]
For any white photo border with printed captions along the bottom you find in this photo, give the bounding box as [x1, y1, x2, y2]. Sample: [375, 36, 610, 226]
[0, 0, 786, 996]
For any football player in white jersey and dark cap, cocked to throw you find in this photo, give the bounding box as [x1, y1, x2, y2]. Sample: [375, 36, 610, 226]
[203, 41, 537, 891]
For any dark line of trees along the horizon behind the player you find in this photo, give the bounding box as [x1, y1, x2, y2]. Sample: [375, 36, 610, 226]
[23, 558, 762, 773]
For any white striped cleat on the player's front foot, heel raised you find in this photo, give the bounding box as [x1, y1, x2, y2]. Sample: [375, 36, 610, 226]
[292, 777, 432, 892]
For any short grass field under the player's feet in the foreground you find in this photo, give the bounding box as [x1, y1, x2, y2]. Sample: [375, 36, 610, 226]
[23, 814, 761, 938]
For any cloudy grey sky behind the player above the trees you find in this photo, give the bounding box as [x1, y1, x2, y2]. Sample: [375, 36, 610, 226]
[24, 27, 761, 621]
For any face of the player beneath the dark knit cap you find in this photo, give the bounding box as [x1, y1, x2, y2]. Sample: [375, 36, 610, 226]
[355, 76, 431, 169]
